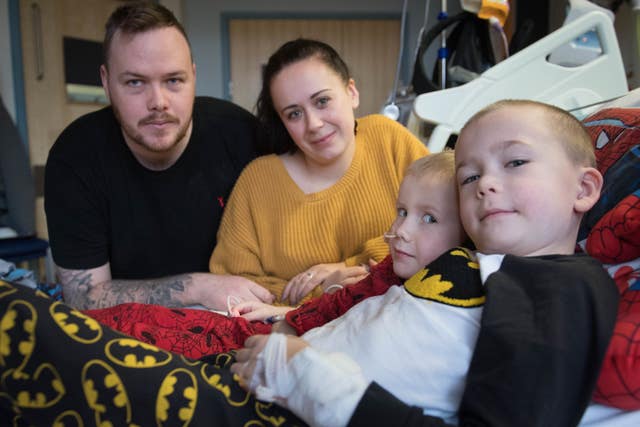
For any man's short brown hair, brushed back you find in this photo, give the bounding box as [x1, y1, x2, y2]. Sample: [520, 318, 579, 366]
[102, 1, 191, 68]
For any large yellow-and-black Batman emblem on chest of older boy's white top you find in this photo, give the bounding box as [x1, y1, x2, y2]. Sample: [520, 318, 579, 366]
[404, 248, 485, 308]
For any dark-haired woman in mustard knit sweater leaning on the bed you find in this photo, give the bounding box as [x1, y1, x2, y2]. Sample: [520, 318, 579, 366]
[209, 39, 428, 304]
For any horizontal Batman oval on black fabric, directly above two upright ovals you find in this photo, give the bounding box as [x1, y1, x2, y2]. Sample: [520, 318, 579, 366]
[105, 338, 172, 368]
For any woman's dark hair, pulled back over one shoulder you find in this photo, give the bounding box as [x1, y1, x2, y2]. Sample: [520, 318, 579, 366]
[256, 38, 351, 154]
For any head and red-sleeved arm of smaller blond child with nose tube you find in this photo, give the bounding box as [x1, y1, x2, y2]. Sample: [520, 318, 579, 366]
[234, 151, 466, 335]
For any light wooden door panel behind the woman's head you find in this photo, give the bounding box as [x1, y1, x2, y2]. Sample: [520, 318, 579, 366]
[229, 19, 400, 116]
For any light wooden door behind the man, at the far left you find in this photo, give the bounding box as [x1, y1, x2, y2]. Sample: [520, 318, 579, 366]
[20, 0, 121, 238]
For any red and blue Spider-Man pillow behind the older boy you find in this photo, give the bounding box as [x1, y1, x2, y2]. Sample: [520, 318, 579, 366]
[579, 108, 640, 410]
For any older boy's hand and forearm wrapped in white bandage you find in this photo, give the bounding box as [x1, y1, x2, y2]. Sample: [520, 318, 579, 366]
[231, 333, 369, 427]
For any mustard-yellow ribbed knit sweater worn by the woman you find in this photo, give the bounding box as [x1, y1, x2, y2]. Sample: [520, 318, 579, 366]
[209, 114, 428, 302]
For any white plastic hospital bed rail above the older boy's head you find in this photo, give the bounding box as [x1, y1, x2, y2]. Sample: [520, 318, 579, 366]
[407, 6, 628, 152]
